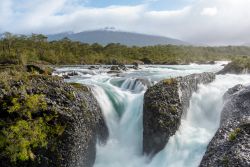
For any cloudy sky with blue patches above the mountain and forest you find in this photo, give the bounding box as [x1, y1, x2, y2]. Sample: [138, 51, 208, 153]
[0, 0, 250, 45]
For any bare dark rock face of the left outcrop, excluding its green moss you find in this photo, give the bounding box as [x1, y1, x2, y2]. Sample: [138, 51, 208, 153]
[0, 75, 108, 167]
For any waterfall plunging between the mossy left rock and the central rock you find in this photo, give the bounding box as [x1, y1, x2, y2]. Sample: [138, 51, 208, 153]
[93, 78, 146, 167]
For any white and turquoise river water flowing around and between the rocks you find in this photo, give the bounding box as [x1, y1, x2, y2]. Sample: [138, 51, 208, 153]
[56, 63, 250, 167]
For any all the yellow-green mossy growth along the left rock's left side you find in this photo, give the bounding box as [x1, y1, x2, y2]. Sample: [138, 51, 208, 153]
[0, 72, 65, 163]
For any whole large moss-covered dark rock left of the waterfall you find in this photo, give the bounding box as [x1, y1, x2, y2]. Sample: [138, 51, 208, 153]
[0, 71, 108, 167]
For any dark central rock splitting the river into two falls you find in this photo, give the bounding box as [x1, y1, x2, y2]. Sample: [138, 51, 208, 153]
[143, 73, 215, 155]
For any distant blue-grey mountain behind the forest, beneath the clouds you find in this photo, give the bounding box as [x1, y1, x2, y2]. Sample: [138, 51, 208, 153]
[48, 30, 188, 46]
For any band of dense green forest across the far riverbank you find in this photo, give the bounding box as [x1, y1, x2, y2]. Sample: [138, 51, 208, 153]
[0, 33, 250, 65]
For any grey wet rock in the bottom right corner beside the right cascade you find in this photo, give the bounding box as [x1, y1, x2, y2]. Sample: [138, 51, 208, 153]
[200, 85, 250, 167]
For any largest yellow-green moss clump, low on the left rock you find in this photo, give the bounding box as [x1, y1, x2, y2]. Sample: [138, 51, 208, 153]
[2, 118, 47, 162]
